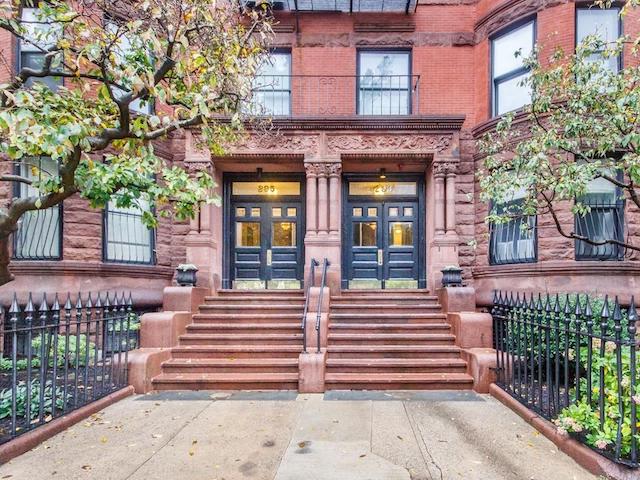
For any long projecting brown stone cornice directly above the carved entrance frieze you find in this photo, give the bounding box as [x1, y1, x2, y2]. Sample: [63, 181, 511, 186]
[258, 115, 465, 131]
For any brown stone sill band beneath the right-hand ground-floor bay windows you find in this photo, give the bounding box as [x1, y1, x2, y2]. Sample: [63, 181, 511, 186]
[472, 260, 640, 279]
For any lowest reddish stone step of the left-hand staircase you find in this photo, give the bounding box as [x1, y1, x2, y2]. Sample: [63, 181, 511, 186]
[152, 372, 298, 390]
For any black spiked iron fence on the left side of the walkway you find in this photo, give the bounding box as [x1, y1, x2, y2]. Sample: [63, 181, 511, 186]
[0, 292, 139, 443]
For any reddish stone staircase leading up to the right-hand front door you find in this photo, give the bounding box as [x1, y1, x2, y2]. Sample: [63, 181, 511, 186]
[325, 290, 473, 390]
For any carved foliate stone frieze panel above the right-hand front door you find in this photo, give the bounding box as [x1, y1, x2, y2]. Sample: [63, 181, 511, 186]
[327, 135, 453, 153]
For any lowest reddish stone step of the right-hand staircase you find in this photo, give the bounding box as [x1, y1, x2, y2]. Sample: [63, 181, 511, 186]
[325, 372, 473, 390]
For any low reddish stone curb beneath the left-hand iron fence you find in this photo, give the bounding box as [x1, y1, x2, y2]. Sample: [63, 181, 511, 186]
[0, 386, 133, 465]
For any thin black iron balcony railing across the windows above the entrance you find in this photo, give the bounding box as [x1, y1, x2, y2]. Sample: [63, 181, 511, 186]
[249, 75, 421, 118]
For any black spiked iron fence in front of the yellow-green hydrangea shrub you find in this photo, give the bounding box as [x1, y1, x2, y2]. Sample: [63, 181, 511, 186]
[492, 292, 640, 467]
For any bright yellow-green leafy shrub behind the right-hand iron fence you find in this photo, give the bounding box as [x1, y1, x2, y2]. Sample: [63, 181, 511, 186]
[554, 339, 640, 457]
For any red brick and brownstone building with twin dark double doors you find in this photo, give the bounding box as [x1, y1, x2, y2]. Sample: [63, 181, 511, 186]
[0, 0, 640, 390]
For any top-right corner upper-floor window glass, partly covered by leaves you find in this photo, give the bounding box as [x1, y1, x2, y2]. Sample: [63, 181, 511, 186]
[576, 7, 622, 72]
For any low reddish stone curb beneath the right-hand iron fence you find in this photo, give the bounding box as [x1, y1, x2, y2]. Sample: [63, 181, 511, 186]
[489, 383, 640, 480]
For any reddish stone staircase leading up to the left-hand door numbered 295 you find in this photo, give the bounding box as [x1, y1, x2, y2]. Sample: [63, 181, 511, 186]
[152, 290, 304, 390]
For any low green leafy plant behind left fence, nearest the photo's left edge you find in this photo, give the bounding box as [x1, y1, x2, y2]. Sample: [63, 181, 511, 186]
[0, 379, 71, 421]
